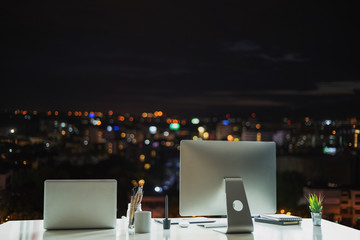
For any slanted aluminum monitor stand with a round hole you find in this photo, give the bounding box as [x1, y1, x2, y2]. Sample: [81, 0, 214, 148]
[214, 178, 254, 233]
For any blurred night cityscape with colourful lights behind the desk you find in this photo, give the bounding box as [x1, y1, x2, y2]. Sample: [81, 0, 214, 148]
[0, 109, 360, 229]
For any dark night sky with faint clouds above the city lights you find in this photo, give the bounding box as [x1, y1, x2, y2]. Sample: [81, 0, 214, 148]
[0, 0, 360, 116]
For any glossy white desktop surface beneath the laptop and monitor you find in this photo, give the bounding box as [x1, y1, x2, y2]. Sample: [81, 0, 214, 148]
[0, 219, 360, 240]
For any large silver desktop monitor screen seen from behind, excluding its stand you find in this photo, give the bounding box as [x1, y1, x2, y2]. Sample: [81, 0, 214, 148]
[179, 140, 276, 232]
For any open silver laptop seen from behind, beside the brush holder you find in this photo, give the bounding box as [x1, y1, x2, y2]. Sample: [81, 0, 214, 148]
[44, 179, 117, 229]
